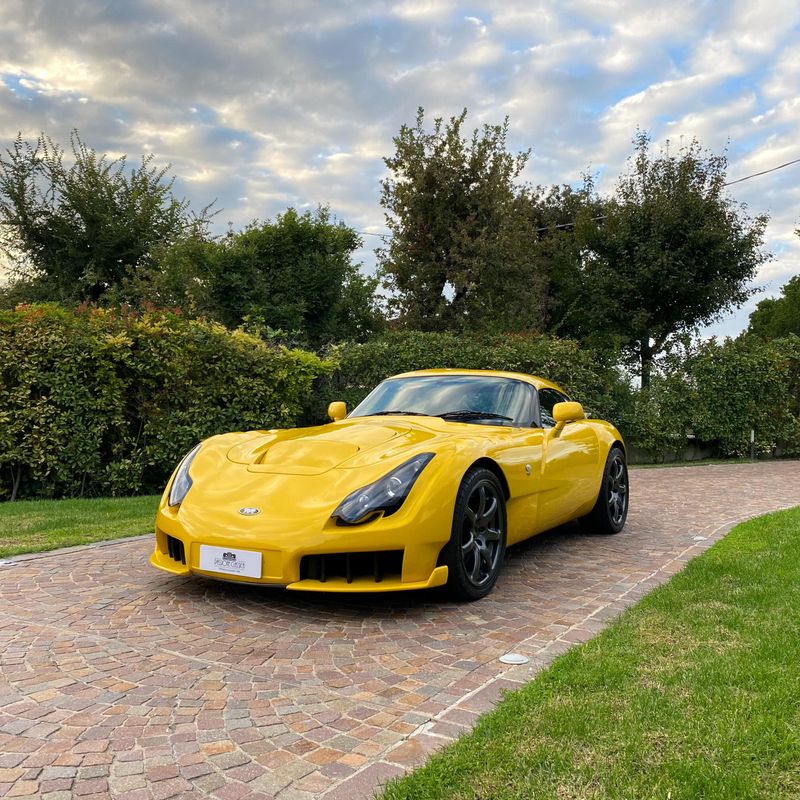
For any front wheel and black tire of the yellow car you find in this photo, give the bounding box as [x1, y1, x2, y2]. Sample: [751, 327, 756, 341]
[442, 467, 508, 601]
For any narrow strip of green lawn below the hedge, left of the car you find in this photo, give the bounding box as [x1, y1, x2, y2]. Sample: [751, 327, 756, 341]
[0, 495, 159, 558]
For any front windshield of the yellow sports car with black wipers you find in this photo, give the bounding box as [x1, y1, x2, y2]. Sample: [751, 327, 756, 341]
[350, 375, 532, 425]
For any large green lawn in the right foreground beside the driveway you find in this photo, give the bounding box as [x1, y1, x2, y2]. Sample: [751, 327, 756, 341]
[384, 508, 800, 800]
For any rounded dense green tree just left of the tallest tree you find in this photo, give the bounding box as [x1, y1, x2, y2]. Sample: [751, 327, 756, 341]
[208, 208, 382, 345]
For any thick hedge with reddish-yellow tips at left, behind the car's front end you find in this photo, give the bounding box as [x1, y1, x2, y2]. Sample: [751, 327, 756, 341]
[0, 305, 332, 498]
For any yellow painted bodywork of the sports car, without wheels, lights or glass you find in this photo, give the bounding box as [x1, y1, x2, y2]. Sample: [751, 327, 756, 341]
[150, 370, 624, 592]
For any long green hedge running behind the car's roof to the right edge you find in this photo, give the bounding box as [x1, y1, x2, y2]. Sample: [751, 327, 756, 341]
[304, 331, 800, 461]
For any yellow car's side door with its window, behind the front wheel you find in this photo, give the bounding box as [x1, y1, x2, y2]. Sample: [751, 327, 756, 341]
[536, 388, 600, 531]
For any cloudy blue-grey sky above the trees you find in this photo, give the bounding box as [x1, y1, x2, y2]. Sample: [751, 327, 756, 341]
[0, 0, 800, 333]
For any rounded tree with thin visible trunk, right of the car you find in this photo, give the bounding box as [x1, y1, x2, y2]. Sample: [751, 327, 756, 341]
[568, 133, 769, 387]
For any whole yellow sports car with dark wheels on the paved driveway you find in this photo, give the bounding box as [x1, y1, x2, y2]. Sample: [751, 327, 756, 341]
[150, 370, 628, 600]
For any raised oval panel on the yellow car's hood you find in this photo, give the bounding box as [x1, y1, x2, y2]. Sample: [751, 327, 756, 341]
[228, 421, 406, 475]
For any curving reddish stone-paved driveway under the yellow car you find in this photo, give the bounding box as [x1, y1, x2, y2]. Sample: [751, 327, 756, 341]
[0, 462, 800, 800]
